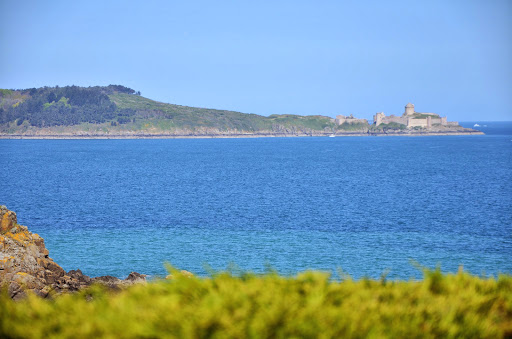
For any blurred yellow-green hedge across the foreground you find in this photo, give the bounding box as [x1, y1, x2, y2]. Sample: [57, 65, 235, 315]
[0, 270, 512, 338]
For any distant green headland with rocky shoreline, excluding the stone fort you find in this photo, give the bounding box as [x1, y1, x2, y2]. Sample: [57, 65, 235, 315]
[0, 85, 483, 139]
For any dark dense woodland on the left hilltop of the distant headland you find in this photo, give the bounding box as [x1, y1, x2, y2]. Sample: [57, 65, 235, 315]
[0, 85, 140, 127]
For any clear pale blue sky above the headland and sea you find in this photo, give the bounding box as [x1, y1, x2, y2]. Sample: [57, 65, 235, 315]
[0, 0, 512, 121]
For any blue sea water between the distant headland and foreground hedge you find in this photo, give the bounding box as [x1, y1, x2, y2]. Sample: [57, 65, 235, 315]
[0, 122, 512, 279]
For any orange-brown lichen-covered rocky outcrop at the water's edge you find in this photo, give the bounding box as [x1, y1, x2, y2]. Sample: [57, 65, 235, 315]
[0, 206, 146, 299]
